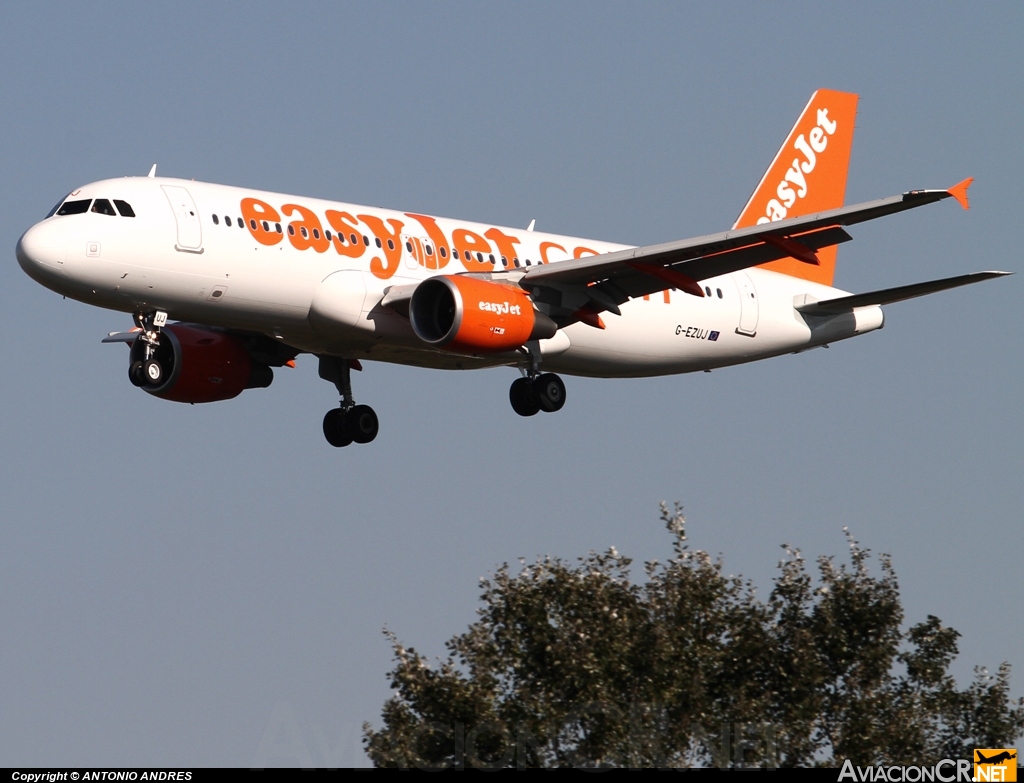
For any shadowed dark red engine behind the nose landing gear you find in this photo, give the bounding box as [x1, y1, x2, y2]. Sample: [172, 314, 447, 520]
[129, 323, 273, 402]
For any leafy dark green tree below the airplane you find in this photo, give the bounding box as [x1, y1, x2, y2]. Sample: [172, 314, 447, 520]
[364, 505, 1024, 768]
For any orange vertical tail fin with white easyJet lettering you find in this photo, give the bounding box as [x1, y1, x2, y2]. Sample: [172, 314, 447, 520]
[732, 90, 857, 286]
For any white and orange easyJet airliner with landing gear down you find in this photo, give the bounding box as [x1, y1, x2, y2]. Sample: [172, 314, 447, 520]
[16, 89, 1010, 447]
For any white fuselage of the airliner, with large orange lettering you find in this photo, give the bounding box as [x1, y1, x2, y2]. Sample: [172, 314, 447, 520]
[17, 177, 883, 377]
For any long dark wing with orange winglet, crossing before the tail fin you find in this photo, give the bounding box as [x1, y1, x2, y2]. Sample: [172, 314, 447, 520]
[505, 179, 971, 325]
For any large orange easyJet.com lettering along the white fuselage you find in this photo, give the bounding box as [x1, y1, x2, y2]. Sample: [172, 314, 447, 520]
[240, 199, 598, 280]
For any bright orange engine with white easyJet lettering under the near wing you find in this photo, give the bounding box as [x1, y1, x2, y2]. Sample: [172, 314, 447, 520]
[409, 274, 558, 353]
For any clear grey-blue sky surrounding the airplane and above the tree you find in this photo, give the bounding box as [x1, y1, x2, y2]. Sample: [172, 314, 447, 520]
[0, 2, 1024, 766]
